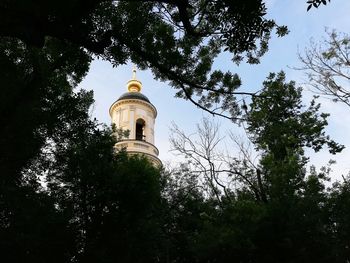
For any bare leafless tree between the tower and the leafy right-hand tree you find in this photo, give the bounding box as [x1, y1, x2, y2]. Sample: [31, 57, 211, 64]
[170, 118, 266, 203]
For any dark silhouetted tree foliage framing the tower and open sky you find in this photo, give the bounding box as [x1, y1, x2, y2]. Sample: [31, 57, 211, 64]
[0, 0, 350, 263]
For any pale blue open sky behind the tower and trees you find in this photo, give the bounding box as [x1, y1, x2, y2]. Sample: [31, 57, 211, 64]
[79, 0, 350, 178]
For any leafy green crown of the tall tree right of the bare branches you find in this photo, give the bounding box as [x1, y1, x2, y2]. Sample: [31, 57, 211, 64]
[248, 72, 344, 156]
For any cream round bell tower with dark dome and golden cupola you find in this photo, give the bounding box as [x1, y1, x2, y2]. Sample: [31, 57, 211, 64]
[109, 67, 162, 166]
